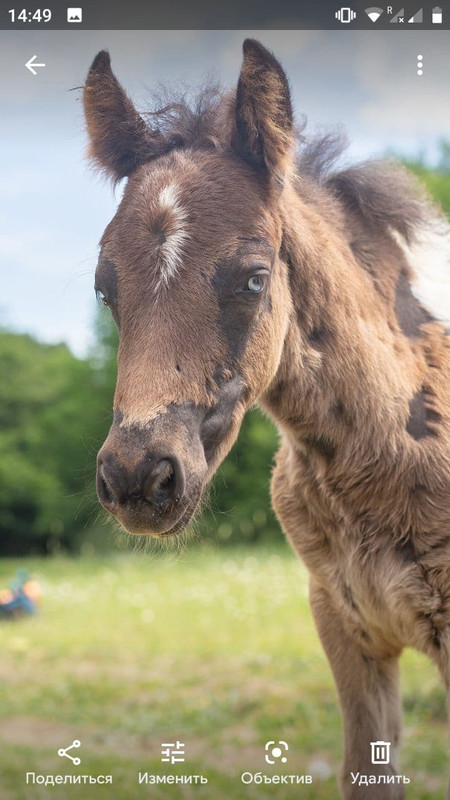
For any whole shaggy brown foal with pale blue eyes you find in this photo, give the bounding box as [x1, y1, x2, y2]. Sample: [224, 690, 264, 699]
[85, 41, 450, 800]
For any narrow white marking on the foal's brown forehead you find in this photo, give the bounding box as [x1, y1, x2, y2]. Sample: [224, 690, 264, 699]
[158, 183, 188, 288]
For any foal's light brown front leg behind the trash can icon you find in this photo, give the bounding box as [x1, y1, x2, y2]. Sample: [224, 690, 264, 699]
[310, 582, 405, 800]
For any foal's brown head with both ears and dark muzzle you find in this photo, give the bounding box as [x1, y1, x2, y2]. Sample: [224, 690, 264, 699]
[84, 40, 294, 535]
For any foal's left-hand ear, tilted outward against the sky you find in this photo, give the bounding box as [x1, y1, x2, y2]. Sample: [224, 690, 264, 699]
[83, 50, 163, 181]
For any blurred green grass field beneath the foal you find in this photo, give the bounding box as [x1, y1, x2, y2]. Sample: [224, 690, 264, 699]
[0, 545, 448, 800]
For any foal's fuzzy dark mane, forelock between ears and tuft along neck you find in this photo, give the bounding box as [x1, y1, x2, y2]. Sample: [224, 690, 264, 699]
[144, 82, 436, 244]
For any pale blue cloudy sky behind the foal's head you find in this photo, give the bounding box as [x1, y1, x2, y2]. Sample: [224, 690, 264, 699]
[0, 30, 450, 356]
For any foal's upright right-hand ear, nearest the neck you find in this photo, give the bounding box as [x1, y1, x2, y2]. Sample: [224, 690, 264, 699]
[232, 39, 294, 183]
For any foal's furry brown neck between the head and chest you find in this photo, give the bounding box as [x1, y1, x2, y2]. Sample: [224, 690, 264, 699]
[262, 181, 450, 468]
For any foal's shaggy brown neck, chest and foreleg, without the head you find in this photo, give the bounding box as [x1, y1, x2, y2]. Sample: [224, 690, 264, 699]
[261, 186, 450, 800]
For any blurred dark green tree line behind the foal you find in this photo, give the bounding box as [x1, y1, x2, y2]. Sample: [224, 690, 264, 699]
[0, 147, 450, 556]
